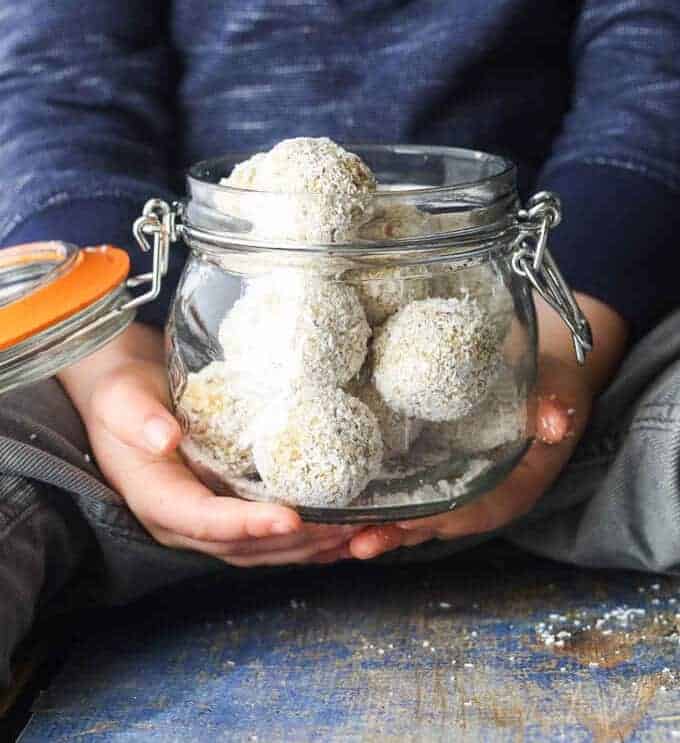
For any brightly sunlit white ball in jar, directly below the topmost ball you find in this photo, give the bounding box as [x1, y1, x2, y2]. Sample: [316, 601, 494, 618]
[219, 269, 371, 395]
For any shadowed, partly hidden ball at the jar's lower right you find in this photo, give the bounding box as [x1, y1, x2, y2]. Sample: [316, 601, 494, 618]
[428, 364, 527, 454]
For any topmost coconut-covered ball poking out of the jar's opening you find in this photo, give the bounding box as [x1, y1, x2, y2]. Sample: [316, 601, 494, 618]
[220, 137, 376, 238]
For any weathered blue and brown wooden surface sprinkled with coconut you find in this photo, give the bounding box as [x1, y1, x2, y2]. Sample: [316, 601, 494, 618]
[21, 547, 680, 743]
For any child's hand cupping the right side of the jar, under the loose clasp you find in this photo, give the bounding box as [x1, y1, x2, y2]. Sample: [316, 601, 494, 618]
[346, 296, 626, 559]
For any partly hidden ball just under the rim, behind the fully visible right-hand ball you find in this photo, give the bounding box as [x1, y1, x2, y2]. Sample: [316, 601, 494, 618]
[344, 266, 430, 328]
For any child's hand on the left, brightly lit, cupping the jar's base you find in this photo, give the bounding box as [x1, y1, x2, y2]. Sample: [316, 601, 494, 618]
[59, 325, 358, 567]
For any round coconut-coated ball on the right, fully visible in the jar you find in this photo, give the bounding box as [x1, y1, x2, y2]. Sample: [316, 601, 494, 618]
[373, 295, 501, 421]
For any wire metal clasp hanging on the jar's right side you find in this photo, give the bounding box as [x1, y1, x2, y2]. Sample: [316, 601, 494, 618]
[512, 191, 593, 364]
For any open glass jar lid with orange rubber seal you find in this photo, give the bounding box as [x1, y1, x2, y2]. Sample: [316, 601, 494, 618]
[0, 242, 134, 393]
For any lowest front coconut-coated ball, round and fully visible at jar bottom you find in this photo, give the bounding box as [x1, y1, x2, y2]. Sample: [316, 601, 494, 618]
[253, 388, 383, 507]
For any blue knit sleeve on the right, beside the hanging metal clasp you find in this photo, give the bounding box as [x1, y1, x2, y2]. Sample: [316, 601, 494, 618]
[540, 0, 680, 335]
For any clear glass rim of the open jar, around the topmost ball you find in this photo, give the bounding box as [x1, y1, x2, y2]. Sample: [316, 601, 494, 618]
[181, 144, 519, 253]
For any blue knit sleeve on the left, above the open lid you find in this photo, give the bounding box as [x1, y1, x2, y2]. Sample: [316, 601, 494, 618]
[0, 0, 182, 322]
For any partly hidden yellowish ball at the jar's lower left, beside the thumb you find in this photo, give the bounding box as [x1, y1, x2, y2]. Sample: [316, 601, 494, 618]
[177, 361, 261, 476]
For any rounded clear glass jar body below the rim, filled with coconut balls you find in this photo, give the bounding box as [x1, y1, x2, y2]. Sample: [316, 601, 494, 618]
[167, 247, 537, 522]
